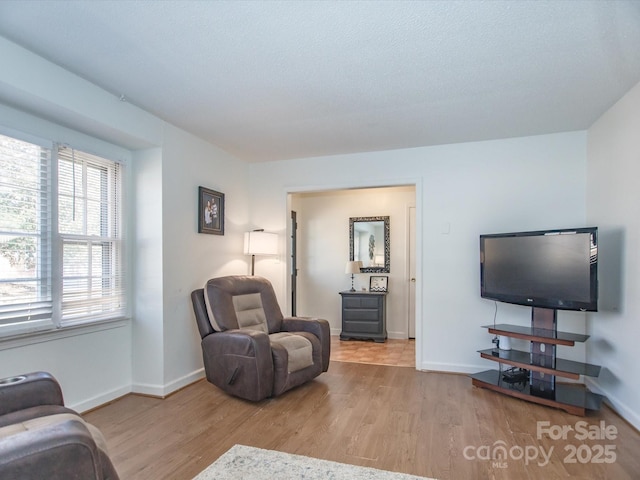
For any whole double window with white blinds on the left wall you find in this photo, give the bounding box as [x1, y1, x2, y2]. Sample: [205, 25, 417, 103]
[0, 131, 125, 336]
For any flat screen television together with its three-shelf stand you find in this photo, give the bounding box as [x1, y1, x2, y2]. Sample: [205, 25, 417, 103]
[471, 227, 604, 416]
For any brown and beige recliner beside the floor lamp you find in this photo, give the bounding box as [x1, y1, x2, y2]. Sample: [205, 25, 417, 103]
[191, 276, 331, 401]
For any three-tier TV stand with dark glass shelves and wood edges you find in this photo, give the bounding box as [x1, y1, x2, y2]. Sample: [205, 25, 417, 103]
[471, 307, 604, 416]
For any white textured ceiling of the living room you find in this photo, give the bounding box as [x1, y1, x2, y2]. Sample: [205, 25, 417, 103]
[0, 0, 640, 161]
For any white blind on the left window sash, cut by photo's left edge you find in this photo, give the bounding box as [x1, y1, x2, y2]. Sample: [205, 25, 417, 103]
[0, 131, 52, 334]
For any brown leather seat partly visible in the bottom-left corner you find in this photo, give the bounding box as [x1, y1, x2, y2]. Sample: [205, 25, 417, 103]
[0, 372, 118, 480]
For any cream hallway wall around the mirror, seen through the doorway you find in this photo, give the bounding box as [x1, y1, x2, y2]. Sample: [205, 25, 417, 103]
[293, 186, 415, 338]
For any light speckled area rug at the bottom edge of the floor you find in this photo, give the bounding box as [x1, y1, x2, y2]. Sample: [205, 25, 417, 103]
[193, 445, 433, 480]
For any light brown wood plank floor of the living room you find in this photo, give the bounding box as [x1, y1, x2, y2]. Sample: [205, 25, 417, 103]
[85, 340, 640, 480]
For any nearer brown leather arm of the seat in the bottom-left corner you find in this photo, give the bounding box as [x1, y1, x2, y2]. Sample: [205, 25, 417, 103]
[0, 420, 111, 480]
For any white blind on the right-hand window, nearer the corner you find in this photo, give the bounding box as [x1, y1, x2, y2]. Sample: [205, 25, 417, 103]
[57, 147, 125, 326]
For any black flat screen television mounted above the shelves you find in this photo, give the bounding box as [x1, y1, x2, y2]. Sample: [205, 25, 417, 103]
[480, 227, 598, 312]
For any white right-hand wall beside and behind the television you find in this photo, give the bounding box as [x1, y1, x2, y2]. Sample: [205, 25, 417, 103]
[587, 79, 640, 428]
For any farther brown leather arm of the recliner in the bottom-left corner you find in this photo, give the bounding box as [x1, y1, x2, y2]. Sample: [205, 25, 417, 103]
[0, 372, 64, 415]
